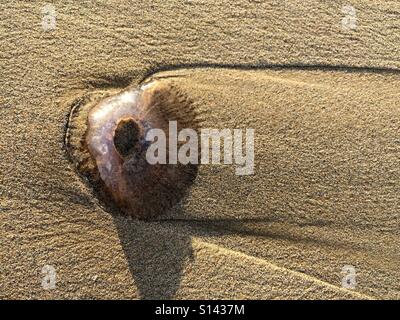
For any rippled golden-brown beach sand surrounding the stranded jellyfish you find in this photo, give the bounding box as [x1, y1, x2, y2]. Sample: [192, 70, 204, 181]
[0, 0, 400, 299]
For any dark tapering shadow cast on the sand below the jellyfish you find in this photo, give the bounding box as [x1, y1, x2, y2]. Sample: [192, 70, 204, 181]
[114, 216, 193, 300]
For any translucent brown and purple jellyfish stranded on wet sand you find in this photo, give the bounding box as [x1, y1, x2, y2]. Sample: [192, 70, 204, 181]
[66, 81, 202, 219]
